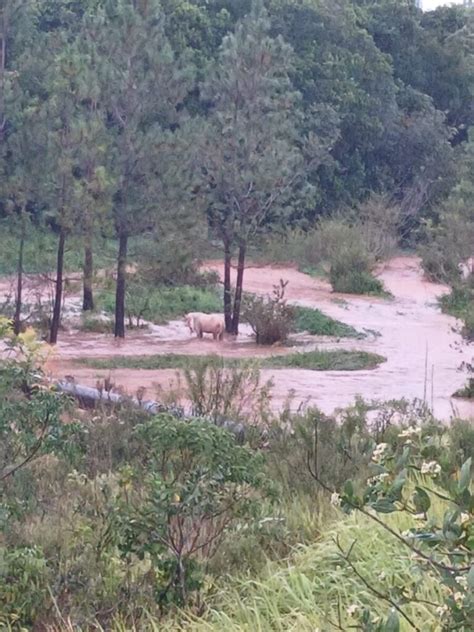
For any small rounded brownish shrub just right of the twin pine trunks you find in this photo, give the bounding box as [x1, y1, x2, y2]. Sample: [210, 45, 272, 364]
[242, 280, 294, 345]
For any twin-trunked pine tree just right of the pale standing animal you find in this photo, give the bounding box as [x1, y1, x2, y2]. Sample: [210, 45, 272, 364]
[201, 3, 325, 334]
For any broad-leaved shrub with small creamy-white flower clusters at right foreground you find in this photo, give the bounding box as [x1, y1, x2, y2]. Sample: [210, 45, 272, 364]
[331, 426, 474, 632]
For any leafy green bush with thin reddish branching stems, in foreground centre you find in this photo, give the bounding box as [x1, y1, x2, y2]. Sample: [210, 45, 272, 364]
[112, 415, 270, 606]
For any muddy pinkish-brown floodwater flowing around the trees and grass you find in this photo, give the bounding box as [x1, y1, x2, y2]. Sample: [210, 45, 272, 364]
[0, 256, 474, 419]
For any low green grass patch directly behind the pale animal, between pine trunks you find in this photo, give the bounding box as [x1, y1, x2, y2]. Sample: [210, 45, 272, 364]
[97, 285, 222, 324]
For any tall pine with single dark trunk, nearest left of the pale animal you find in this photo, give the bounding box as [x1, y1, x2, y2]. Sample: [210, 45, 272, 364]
[97, 0, 192, 338]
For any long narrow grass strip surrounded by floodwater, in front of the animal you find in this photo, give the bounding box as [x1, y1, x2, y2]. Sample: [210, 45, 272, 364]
[77, 350, 385, 371]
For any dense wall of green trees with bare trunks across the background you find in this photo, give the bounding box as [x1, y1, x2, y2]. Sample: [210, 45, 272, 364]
[0, 0, 474, 342]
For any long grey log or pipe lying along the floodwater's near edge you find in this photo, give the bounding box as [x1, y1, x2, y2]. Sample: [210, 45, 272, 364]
[54, 380, 245, 441]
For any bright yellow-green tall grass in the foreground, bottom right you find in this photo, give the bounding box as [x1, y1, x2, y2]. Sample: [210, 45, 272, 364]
[173, 516, 442, 632]
